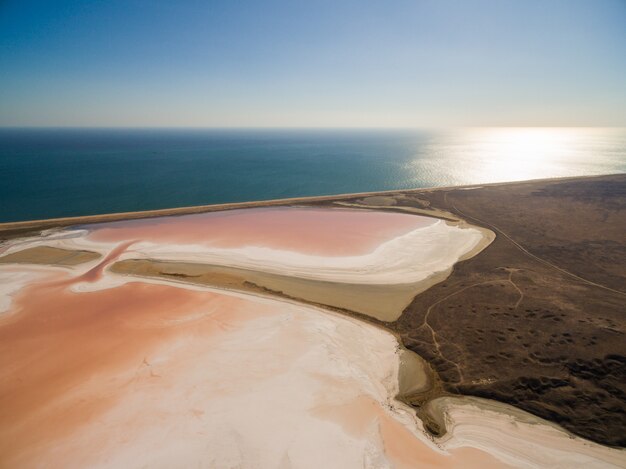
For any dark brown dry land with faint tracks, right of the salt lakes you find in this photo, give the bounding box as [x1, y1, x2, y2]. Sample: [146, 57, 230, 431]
[316, 175, 626, 447]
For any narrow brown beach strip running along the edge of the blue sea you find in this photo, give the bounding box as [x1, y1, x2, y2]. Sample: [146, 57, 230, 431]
[0, 173, 625, 240]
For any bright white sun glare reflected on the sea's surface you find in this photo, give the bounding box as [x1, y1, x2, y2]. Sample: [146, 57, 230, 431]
[410, 127, 621, 185]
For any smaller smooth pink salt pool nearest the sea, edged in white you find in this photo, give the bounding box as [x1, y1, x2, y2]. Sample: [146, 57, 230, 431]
[87, 207, 437, 256]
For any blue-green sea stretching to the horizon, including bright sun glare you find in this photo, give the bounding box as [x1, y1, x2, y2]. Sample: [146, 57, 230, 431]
[0, 128, 626, 222]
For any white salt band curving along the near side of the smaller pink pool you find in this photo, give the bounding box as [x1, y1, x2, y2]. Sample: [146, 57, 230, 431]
[0, 220, 484, 284]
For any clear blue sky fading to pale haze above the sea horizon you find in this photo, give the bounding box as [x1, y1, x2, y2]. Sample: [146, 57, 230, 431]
[0, 0, 626, 127]
